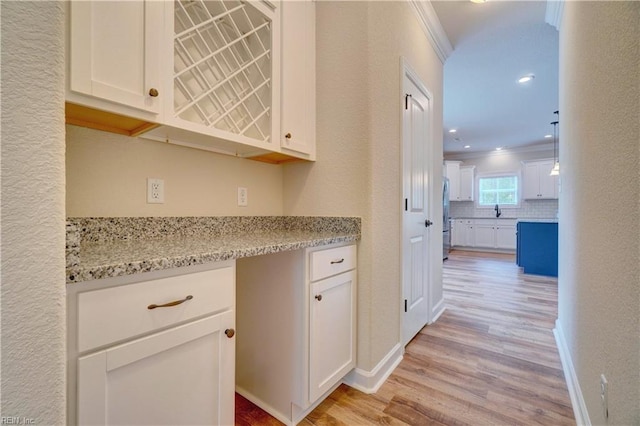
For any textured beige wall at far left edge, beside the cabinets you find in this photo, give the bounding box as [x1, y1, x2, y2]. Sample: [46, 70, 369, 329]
[1, 2, 66, 425]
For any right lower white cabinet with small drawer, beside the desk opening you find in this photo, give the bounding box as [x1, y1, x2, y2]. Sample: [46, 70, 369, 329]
[236, 245, 357, 424]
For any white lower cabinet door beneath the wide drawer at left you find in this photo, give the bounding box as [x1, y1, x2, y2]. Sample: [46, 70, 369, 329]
[78, 311, 234, 425]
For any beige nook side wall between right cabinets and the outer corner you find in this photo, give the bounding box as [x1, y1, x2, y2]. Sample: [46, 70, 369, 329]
[284, 2, 372, 368]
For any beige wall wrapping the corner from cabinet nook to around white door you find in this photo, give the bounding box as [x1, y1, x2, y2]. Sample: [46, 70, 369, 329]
[284, 1, 442, 370]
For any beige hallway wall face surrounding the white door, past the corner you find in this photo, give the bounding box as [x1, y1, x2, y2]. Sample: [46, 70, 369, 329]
[368, 1, 443, 365]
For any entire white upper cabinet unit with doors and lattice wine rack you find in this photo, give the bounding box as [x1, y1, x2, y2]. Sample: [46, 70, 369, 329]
[66, 0, 315, 163]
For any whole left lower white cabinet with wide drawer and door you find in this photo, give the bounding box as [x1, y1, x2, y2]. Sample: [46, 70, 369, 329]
[68, 262, 235, 425]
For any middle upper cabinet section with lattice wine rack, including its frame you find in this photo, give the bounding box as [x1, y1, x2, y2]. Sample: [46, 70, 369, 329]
[151, 0, 280, 155]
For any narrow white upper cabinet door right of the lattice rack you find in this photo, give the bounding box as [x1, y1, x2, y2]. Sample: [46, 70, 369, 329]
[280, 0, 316, 159]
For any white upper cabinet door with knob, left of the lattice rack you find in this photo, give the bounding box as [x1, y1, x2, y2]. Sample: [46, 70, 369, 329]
[67, 0, 164, 121]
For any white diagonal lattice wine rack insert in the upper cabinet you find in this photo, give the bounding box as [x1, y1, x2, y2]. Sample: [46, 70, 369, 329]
[173, 0, 273, 143]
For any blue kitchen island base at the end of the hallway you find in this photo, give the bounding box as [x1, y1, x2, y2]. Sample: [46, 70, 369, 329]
[516, 220, 558, 277]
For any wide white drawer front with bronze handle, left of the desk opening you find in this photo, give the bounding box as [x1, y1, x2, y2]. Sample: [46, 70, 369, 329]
[78, 266, 235, 352]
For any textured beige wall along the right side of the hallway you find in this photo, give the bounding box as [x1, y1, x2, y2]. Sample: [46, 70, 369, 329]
[558, 2, 640, 425]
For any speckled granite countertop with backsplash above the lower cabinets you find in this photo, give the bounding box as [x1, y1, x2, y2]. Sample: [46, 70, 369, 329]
[66, 216, 360, 284]
